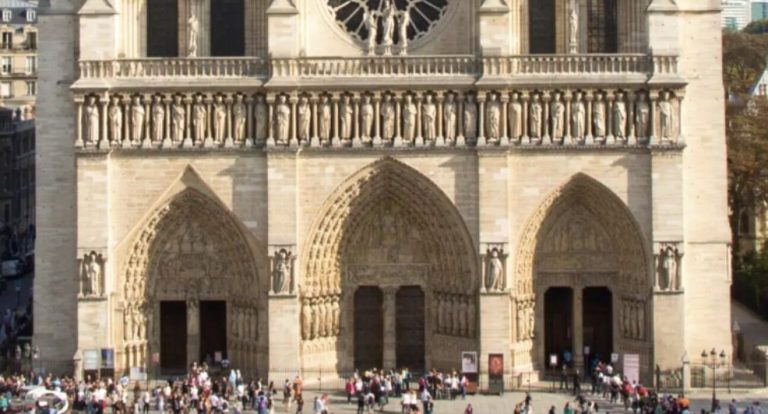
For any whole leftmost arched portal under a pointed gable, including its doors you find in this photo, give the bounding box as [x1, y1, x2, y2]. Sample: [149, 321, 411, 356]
[118, 189, 265, 372]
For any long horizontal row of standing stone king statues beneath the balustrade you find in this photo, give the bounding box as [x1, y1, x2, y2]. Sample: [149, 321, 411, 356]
[75, 90, 680, 149]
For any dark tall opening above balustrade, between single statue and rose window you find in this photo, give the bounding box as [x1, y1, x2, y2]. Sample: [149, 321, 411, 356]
[211, 0, 245, 56]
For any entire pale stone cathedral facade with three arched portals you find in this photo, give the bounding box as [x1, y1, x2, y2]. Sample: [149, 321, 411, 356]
[34, 0, 731, 385]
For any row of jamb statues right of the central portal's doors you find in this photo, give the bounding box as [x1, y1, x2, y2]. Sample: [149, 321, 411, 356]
[433, 292, 477, 338]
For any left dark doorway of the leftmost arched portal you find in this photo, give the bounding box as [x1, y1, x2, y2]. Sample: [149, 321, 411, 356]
[160, 301, 187, 373]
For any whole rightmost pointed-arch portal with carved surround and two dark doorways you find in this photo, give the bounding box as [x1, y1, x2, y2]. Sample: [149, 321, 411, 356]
[513, 174, 653, 378]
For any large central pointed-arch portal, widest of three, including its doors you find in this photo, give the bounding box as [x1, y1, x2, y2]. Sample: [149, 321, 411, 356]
[300, 158, 479, 370]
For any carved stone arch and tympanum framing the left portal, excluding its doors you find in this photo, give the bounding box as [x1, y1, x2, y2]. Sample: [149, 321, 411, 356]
[122, 190, 259, 366]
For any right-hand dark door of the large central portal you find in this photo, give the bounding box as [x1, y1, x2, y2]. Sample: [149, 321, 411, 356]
[396, 286, 426, 372]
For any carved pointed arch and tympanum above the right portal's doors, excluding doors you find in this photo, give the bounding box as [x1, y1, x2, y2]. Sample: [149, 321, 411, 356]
[515, 175, 650, 295]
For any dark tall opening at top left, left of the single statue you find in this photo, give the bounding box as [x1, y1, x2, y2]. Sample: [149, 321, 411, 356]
[147, 0, 179, 57]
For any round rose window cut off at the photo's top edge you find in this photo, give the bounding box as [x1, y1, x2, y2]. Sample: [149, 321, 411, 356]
[328, 0, 449, 44]
